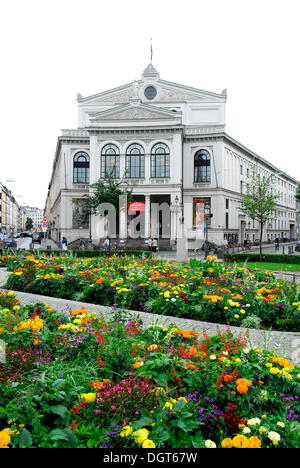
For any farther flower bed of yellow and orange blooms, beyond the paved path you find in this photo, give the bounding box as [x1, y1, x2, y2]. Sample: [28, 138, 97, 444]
[1, 255, 300, 331]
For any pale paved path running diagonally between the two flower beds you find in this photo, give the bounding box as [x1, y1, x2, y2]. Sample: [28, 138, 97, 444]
[0, 268, 300, 365]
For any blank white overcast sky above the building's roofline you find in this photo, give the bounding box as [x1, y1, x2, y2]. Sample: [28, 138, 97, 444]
[0, 0, 300, 208]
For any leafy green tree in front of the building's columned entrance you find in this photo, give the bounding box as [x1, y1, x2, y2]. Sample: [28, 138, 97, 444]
[83, 173, 134, 239]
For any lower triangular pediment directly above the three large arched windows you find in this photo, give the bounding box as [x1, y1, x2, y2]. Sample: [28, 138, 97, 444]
[89, 102, 181, 124]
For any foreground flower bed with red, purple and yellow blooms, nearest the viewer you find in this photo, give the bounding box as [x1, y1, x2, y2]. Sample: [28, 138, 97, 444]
[0, 292, 300, 449]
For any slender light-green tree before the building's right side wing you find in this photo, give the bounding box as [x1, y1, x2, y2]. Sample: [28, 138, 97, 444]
[239, 168, 278, 261]
